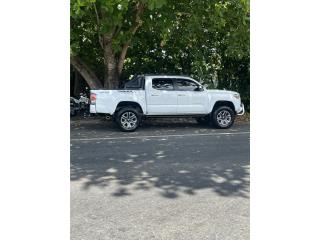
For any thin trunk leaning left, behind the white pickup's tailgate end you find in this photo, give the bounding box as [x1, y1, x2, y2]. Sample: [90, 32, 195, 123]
[70, 57, 103, 89]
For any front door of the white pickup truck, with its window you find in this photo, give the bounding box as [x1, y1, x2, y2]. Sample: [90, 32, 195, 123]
[175, 78, 209, 114]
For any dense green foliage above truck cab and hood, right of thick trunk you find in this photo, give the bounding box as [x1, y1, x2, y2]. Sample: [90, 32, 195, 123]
[123, 0, 250, 101]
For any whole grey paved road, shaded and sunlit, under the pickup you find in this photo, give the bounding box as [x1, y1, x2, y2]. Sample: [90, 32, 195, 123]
[71, 120, 250, 240]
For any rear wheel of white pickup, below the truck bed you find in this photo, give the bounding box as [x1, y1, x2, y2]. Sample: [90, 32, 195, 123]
[116, 107, 141, 132]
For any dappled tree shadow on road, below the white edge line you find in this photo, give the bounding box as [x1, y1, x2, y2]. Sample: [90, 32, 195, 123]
[71, 124, 249, 199]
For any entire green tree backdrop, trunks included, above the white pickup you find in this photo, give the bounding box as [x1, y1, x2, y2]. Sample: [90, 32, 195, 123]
[71, 0, 250, 106]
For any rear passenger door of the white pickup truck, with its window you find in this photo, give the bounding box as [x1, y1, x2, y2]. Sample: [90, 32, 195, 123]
[146, 77, 177, 115]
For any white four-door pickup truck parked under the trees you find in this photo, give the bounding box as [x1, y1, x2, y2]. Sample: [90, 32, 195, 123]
[90, 75, 244, 132]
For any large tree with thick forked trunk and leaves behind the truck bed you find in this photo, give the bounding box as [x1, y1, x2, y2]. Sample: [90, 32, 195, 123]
[70, 0, 165, 89]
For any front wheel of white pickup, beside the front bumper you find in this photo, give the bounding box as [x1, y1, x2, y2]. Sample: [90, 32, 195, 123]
[212, 106, 235, 129]
